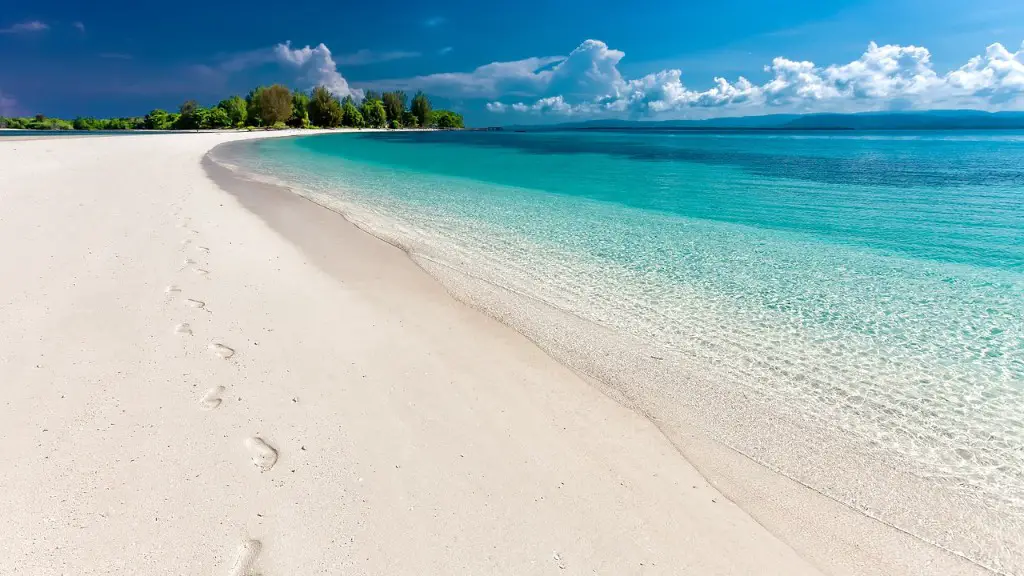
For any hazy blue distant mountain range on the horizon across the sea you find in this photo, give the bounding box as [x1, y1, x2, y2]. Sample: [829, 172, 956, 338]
[504, 110, 1024, 131]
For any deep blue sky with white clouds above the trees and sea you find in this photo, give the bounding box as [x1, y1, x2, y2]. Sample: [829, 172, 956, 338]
[0, 0, 1024, 126]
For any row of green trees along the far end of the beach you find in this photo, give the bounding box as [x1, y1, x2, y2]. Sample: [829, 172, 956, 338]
[0, 84, 464, 130]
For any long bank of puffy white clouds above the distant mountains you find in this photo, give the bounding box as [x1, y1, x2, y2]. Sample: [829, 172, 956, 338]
[475, 40, 1024, 117]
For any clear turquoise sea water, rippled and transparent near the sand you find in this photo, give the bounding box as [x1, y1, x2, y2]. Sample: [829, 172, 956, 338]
[223, 132, 1024, 569]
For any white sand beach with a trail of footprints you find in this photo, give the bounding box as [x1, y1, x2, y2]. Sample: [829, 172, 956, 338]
[0, 133, 987, 576]
